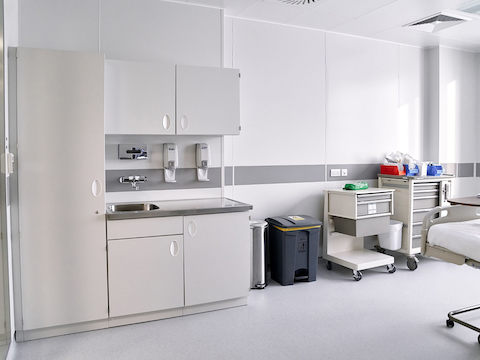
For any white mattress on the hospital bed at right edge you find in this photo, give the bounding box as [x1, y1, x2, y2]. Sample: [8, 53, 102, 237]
[428, 219, 480, 262]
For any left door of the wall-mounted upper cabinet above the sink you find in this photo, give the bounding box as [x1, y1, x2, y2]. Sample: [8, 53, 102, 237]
[105, 60, 175, 135]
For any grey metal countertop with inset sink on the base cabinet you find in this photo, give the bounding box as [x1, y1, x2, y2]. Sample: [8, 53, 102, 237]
[106, 198, 253, 220]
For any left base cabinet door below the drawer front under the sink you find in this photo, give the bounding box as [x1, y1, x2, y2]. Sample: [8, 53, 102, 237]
[108, 235, 184, 317]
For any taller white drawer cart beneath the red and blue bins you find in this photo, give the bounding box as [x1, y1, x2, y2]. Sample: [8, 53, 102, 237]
[378, 174, 453, 271]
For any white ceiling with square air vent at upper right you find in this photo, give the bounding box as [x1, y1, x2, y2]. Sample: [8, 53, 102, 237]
[170, 0, 480, 52]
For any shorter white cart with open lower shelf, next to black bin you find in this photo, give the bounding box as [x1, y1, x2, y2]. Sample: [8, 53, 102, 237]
[323, 188, 396, 281]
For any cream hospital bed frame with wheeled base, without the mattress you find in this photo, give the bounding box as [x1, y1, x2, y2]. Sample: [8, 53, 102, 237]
[422, 205, 480, 343]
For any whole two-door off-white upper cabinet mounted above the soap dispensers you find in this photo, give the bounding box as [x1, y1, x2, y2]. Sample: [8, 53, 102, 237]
[105, 60, 240, 135]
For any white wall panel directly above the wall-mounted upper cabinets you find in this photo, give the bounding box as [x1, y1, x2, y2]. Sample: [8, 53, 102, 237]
[100, 0, 223, 66]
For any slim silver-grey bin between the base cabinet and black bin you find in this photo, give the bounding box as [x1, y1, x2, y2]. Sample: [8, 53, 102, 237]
[250, 220, 268, 289]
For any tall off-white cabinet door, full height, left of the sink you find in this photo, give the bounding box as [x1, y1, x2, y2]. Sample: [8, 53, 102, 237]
[12, 48, 108, 330]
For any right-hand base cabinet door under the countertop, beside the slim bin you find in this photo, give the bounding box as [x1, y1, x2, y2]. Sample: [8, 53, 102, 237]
[184, 212, 250, 306]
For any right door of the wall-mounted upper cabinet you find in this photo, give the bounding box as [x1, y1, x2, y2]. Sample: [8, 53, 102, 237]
[176, 65, 240, 135]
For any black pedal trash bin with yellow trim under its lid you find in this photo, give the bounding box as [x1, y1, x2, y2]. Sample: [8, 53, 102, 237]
[265, 215, 322, 285]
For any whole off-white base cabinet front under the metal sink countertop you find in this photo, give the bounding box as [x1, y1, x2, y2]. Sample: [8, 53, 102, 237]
[107, 211, 250, 322]
